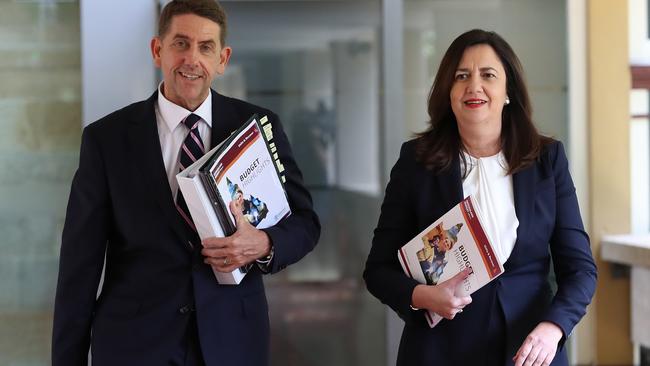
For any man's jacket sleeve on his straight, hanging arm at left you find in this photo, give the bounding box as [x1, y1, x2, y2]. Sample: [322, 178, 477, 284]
[52, 127, 110, 366]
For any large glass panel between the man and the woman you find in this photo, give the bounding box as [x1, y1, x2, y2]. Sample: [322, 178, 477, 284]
[214, 1, 386, 365]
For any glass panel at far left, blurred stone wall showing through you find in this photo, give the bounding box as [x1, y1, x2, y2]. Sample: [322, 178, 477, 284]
[0, 1, 81, 365]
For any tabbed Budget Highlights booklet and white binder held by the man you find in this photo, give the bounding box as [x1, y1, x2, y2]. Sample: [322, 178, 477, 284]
[176, 115, 291, 284]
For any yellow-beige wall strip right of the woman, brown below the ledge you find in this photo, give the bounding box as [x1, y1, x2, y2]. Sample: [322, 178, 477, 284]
[587, 0, 632, 365]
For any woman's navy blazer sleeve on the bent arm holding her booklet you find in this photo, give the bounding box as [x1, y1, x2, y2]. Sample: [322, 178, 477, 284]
[363, 142, 418, 321]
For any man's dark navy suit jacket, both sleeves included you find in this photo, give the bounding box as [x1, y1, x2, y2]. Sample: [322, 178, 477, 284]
[52, 91, 320, 366]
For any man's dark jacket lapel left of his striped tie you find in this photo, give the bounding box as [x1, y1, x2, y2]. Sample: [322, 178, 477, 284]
[128, 91, 191, 250]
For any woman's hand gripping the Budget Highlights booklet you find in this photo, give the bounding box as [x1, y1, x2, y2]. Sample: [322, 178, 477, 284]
[411, 268, 472, 320]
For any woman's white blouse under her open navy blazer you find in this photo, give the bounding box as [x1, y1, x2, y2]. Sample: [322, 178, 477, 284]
[460, 152, 519, 263]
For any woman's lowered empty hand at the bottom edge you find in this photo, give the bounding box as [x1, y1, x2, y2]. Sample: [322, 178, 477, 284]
[512, 322, 562, 366]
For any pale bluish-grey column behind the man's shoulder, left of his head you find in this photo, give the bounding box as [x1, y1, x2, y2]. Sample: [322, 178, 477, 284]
[80, 0, 158, 125]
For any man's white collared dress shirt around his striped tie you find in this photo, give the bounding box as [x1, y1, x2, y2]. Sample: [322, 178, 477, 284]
[156, 83, 212, 201]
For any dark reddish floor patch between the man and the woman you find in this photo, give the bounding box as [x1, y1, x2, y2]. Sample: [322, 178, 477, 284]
[268, 281, 385, 366]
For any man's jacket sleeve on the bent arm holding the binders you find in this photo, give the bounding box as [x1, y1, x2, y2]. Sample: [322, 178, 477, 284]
[263, 112, 320, 273]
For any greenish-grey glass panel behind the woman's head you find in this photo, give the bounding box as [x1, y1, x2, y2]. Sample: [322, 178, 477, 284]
[404, 0, 568, 145]
